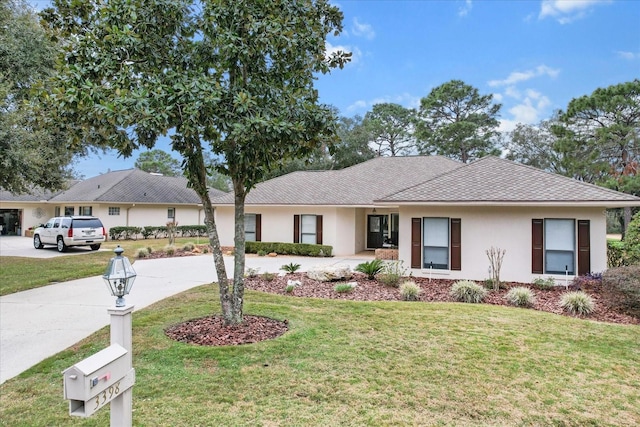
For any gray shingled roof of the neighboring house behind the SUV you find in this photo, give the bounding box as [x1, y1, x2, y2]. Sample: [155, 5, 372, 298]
[49, 169, 224, 205]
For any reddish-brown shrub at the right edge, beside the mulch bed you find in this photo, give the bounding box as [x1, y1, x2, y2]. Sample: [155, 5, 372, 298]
[602, 264, 640, 317]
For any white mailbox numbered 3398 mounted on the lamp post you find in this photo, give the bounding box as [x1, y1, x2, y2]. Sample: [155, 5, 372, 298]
[62, 344, 135, 417]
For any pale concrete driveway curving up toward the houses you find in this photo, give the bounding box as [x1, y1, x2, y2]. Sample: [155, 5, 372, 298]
[0, 237, 371, 383]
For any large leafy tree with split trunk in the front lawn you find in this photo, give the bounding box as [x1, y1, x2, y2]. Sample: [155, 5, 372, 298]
[45, 0, 350, 323]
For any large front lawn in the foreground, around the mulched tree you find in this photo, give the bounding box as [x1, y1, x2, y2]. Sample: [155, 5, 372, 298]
[0, 285, 640, 426]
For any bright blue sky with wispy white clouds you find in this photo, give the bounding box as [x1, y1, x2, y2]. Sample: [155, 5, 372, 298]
[30, 0, 640, 177]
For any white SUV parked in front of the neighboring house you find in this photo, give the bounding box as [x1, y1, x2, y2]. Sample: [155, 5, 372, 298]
[33, 216, 107, 252]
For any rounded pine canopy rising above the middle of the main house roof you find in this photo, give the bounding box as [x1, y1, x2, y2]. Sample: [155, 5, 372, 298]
[416, 80, 501, 163]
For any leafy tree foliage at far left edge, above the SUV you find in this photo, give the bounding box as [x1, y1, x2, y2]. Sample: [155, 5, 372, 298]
[0, 0, 73, 193]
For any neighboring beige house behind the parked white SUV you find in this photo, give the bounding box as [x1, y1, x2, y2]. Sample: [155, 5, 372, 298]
[0, 169, 225, 235]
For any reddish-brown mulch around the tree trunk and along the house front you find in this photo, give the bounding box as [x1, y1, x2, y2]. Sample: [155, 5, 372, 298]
[165, 273, 640, 346]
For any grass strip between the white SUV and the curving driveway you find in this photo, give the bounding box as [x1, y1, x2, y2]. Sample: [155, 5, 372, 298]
[0, 237, 207, 296]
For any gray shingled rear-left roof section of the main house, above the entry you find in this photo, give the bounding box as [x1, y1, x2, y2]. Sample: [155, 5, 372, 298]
[212, 156, 460, 206]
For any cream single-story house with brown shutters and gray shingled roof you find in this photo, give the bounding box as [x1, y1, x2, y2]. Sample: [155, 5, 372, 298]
[212, 156, 640, 282]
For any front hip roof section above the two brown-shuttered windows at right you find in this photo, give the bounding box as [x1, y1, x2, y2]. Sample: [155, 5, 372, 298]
[377, 156, 640, 207]
